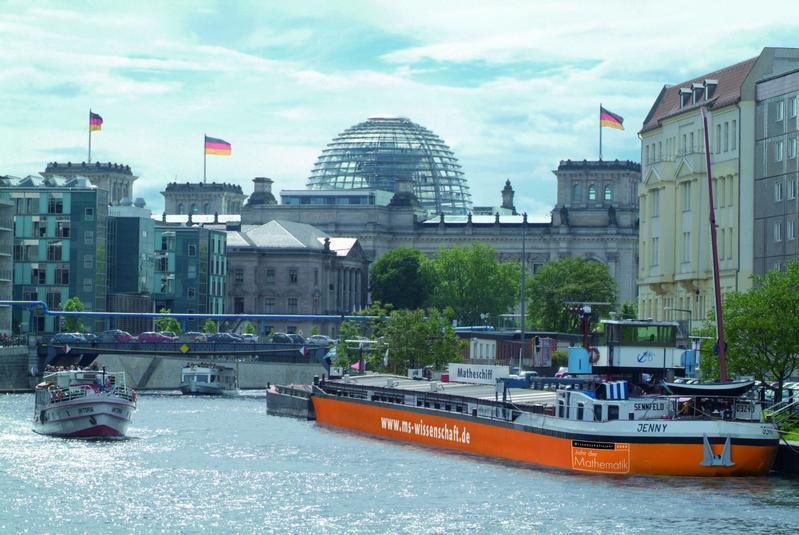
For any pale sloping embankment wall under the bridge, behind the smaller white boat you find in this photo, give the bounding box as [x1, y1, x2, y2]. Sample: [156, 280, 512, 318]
[95, 355, 325, 390]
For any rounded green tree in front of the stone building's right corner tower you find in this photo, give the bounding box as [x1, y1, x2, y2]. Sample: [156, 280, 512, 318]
[527, 257, 616, 332]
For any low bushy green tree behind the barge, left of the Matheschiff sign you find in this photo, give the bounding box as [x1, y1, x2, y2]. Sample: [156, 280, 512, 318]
[373, 308, 466, 375]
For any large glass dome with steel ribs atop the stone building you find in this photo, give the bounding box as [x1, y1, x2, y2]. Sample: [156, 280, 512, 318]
[307, 117, 472, 214]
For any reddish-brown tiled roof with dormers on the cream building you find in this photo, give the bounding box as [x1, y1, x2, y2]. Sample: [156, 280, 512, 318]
[641, 56, 759, 132]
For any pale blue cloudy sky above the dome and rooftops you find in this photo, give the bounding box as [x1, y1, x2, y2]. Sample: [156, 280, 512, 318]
[0, 0, 799, 217]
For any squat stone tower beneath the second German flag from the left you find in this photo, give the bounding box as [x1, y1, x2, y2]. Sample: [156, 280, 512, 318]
[161, 182, 246, 215]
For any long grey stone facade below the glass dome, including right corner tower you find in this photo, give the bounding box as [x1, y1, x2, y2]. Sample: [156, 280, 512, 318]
[241, 160, 640, 301]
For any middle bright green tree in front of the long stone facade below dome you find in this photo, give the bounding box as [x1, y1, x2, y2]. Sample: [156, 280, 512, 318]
[426, 242, 521, 325]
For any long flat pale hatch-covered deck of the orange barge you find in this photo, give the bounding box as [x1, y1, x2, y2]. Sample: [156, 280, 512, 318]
[333, 374, 555, 404]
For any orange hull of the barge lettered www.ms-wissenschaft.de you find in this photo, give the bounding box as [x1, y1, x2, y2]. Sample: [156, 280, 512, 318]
[312, 393, 777, 477]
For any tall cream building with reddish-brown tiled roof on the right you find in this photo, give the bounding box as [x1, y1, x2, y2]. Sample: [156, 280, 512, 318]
[638, 48, 799, 327]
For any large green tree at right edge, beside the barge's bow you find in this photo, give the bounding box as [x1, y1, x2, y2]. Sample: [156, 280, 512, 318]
[702, 262, 799, 401]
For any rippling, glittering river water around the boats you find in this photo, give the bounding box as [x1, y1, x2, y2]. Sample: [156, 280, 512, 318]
[0, 393, 799, 535]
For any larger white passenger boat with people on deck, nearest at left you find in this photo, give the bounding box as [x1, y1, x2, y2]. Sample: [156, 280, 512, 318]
[33, 370, 136, 438]
